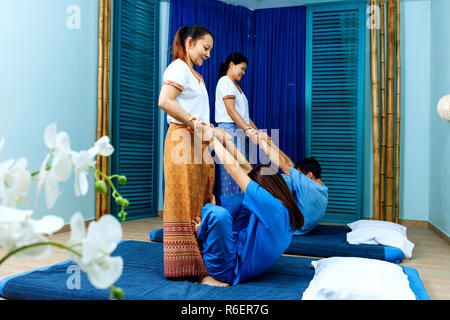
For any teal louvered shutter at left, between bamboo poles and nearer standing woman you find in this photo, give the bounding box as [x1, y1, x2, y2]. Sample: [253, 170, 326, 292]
[111, 0, 159, 219]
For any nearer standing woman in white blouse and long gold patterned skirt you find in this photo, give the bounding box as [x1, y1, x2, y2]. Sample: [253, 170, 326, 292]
[158, 25, 226, 285]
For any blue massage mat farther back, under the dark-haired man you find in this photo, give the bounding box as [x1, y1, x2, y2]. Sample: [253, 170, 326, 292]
[150, 224, 404, 264]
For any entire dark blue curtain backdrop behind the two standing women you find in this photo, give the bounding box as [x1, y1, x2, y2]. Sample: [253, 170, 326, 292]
[168, 0, 306, 162]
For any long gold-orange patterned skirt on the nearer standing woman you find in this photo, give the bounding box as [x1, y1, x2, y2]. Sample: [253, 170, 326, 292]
[163, 123, 214, 277]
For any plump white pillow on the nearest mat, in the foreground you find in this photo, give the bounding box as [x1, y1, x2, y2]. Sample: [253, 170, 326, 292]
[302, 257, 416, 300]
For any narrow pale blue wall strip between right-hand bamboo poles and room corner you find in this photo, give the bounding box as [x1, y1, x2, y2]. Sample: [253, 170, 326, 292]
[400, 0, 431, 220]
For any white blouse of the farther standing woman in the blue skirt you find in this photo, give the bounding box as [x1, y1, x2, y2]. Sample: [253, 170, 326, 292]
[215, 76, 250, 123]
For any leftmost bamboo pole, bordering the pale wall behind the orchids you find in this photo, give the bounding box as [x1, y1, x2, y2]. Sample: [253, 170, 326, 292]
[95, 0, 105, 220]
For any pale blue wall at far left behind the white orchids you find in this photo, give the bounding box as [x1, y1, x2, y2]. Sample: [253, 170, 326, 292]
[0, 0, 98, 223]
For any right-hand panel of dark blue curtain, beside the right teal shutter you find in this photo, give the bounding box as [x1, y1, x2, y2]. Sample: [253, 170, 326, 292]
[249, 7, 306, 162]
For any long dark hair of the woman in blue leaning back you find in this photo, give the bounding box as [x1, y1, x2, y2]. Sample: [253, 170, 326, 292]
[248, 164, 304, 230]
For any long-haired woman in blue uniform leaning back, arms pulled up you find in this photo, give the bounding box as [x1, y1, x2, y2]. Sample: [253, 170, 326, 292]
[192, 123, 303, 285]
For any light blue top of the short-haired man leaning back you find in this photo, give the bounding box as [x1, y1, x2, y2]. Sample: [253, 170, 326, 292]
[283, 167, 328, 235]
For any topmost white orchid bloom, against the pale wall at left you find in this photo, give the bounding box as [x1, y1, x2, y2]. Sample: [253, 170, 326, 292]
[36, 123, 73, 208]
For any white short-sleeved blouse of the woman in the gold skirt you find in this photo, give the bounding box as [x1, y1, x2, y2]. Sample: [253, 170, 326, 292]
[163, 59, 210, 124]
